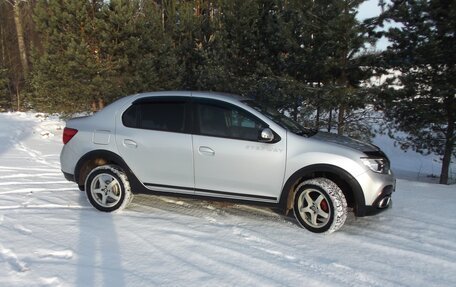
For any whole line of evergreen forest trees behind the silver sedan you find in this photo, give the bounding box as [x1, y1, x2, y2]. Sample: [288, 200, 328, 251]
[0, 0, 456, 183]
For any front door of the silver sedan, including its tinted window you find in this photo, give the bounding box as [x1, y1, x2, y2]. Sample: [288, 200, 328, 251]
[193, 99, 286, 202]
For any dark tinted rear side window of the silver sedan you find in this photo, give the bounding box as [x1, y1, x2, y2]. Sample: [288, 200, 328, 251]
[122, 101, 186, 132]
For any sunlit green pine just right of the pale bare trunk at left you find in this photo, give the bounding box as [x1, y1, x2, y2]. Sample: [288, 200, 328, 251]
[30, 0, 109, 112]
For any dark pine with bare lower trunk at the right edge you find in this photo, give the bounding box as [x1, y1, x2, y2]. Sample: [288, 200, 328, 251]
[383, 0, 456, 184]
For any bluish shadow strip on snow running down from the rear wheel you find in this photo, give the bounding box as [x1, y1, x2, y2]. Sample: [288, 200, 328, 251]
[76, 192, 126, 286]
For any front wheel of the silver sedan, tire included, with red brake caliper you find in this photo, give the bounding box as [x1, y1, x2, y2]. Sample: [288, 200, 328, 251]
[293, 178, 347, 233]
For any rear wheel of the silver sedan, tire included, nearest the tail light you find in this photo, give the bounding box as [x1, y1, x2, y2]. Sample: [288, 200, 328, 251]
[85, 165, 133, 212]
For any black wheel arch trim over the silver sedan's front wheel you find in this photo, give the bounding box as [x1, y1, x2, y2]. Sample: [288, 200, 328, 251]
[279, 164, 366, 216]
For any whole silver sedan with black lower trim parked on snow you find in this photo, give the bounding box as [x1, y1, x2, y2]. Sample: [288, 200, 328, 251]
[60, 91, 395, 233]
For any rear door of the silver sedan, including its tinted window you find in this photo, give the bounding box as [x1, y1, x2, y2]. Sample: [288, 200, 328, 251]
[116, 96, 194, 194]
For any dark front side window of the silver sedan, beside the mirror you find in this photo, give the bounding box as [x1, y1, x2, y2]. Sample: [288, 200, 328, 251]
[197, 103, 266, 141]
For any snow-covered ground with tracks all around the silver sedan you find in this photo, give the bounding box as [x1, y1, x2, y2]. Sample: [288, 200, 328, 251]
[0, 113, 456, 287]
